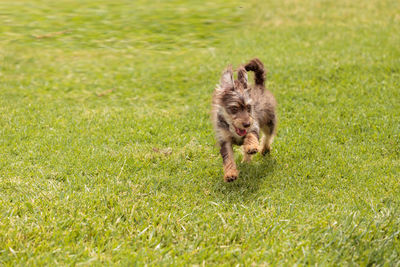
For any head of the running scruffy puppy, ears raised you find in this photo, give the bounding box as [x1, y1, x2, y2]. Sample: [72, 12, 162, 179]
[217, 67, 254, 136]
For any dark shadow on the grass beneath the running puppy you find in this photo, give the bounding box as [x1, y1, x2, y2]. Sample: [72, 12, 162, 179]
[213, 155, 276, 203]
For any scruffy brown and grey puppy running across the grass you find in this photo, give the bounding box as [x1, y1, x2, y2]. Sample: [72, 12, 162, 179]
[212, 58, 277, 182]
